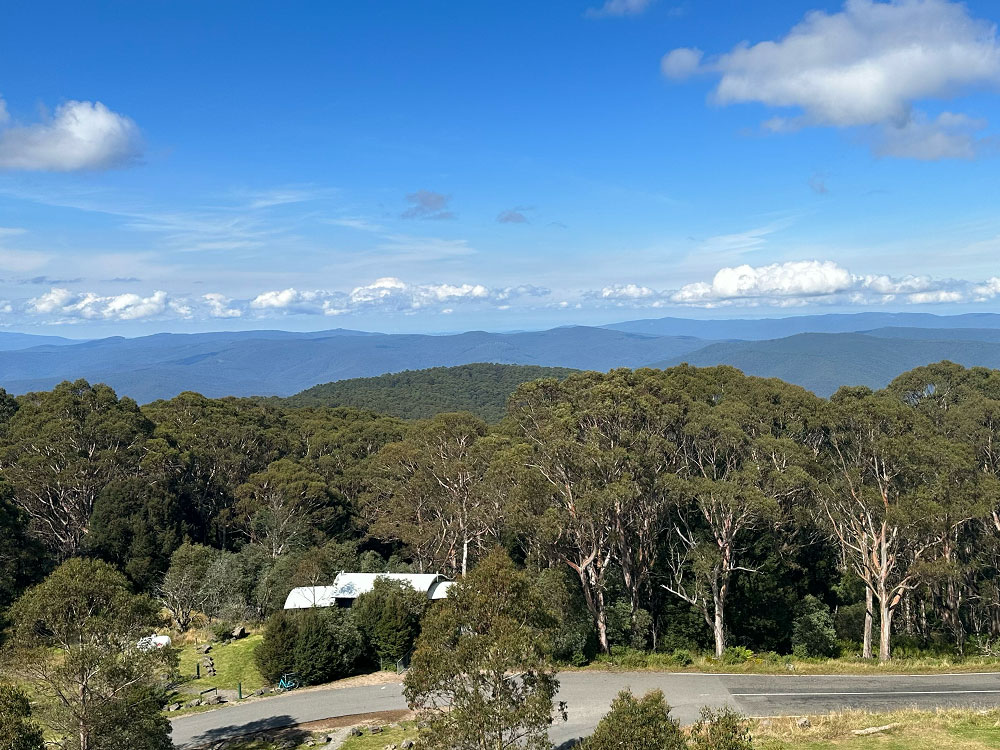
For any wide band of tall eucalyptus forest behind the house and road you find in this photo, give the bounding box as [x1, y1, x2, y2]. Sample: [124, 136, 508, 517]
[0, 363, 1000, 661]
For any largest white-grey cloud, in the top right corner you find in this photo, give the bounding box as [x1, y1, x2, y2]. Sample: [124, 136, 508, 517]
[661, 0, 1000, 159]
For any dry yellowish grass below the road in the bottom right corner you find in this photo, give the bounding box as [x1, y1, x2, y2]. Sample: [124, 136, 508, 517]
[754, 709, 1000, 750]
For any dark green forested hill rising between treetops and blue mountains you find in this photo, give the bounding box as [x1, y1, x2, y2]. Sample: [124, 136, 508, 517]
[281, 362, 575, 422]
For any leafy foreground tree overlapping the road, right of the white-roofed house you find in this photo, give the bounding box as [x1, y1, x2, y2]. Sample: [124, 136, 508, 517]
[403, 552, 558, 750]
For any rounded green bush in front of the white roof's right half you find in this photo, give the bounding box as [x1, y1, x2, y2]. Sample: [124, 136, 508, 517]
[351, 578, 429, 664]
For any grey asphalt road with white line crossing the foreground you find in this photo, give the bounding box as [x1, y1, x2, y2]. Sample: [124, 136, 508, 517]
[173, 671, 1000, 748]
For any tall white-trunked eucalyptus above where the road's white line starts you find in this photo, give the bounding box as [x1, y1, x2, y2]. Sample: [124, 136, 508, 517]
[661, 366, 819, 656]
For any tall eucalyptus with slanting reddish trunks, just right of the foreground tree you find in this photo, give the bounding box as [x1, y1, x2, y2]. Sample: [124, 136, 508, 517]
[507, 369, 673, 651]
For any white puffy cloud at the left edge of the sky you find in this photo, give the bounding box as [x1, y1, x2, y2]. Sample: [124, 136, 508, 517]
[0, 99, 142, 172]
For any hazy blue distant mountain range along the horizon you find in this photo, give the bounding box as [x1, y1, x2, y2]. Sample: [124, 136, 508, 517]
[0, 313, 1000, 403]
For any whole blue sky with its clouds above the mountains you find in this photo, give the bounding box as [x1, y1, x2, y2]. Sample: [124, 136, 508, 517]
[0, 0, 1000, 336]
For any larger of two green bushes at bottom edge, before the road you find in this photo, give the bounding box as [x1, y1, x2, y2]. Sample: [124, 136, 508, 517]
[583, 690, 687, 750]
